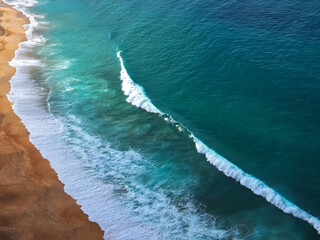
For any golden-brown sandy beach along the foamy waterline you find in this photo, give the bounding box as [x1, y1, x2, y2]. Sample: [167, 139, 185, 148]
[0, 0, 103, 240]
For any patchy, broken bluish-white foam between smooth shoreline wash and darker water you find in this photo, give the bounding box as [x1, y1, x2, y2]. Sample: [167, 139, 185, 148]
[64, 116, 239, 239]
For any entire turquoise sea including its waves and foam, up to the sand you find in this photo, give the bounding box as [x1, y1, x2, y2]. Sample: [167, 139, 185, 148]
[6, 0, 320, 239]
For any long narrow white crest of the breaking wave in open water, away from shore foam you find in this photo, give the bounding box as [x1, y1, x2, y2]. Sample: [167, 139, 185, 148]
[117, 51, 320, 235]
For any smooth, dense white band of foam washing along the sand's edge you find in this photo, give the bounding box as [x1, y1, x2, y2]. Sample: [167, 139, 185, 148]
[6, 0, 160, 240]
